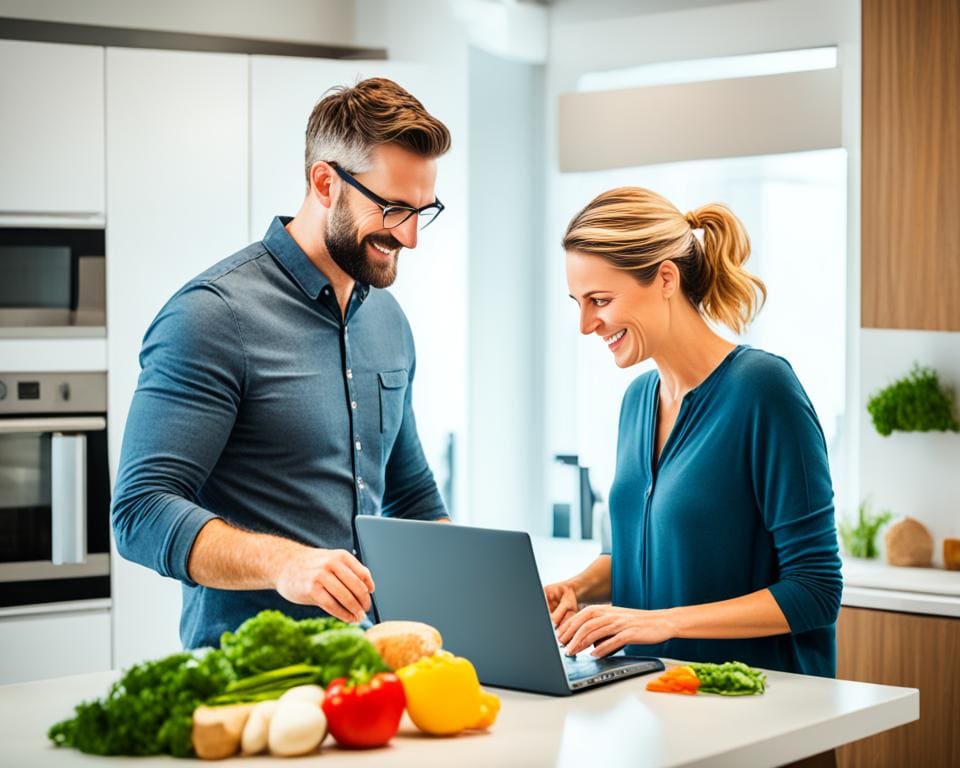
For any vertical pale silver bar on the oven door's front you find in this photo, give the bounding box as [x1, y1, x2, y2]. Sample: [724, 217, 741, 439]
[50, 432, 87, 565]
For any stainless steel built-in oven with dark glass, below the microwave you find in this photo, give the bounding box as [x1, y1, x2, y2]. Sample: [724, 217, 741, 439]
[0, 373, 110, 608]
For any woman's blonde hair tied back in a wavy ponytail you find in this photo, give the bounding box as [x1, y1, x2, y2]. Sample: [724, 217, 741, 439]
[563, 187, 767, 333]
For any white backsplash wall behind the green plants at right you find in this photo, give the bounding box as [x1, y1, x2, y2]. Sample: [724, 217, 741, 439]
[859, 328, 960, 565]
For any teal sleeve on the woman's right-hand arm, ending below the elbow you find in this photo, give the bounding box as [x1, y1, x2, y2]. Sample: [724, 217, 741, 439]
[750, 362, 843, 634]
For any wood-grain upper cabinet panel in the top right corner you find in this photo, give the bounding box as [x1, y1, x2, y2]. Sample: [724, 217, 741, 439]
[861, 0, 960, 331]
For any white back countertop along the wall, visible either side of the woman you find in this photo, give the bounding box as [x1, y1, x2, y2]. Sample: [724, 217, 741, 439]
[532, 537, 960, 618]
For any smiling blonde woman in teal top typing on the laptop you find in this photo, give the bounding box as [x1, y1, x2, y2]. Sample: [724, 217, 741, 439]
[545, 187, 842, 677]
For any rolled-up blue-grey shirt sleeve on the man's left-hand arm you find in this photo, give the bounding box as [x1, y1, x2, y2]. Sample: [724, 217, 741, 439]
[111, 283, 246, 586]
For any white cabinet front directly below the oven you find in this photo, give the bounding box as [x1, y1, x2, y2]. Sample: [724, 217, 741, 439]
[0, 606, 111, 685]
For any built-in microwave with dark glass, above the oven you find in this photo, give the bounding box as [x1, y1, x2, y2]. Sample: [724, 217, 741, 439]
[0, 227, 107, 337]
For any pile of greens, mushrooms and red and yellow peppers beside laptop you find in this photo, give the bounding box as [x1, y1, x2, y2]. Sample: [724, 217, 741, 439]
[49, 611, 500, 759]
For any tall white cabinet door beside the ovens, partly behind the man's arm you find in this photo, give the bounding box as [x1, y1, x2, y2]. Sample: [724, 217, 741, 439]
[106, 48, 249, 666]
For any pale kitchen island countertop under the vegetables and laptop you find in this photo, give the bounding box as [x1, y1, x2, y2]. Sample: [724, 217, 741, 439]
[0, 663, 920, 768]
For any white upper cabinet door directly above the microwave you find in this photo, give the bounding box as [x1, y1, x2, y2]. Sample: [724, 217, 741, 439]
[0, 40, 104, 214]
